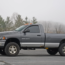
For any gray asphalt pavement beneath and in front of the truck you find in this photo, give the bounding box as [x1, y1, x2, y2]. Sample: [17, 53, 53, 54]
[0, 49, 65, 65]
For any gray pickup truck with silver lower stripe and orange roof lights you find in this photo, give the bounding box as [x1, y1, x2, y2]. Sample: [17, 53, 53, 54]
[0, 24, 65, 56]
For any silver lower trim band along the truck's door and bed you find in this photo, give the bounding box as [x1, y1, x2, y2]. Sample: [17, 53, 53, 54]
[20, 42, 60, 48]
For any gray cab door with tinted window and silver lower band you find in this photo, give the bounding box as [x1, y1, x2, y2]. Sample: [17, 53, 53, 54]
[21, 25, 43, 47]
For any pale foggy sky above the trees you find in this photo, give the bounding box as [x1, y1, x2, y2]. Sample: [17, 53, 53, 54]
[0, 0, 65, 24]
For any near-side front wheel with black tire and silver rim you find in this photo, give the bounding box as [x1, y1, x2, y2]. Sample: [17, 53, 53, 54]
[5, 42, 20, 56]
